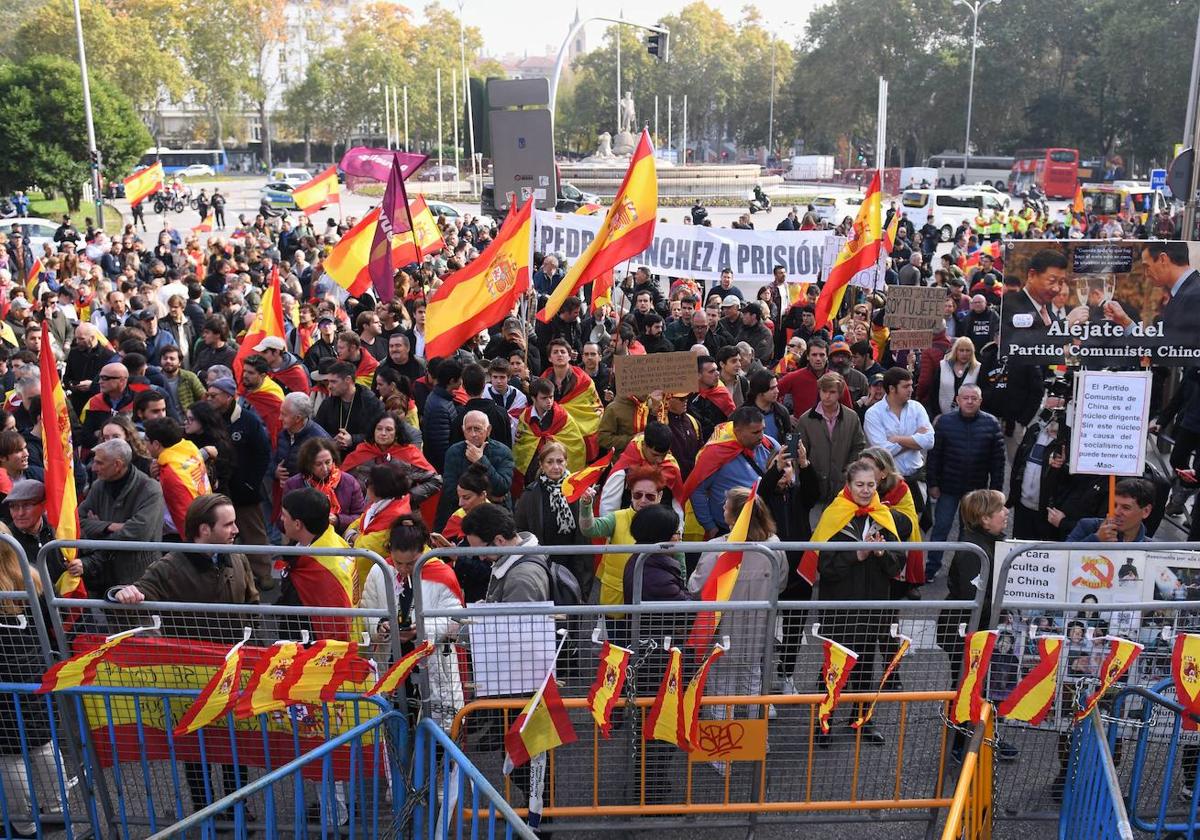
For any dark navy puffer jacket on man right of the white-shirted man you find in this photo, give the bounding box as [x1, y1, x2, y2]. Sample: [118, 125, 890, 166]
[926, 409, 1004, 496]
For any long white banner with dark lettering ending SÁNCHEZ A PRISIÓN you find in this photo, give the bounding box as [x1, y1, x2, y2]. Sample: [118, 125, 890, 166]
[533, 210, 827, 296]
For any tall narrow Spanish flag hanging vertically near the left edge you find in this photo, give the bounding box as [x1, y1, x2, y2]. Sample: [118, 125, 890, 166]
[37, 330, 79, 564]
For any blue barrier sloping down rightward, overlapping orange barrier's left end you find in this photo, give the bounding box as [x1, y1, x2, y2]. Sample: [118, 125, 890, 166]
[412, 718, 538, 840]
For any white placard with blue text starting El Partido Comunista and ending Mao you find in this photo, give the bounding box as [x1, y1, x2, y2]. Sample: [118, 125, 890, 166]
[1070, 371, 1151, 476]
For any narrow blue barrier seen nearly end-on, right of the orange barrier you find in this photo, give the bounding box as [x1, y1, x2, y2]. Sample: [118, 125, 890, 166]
[1058, 710, 1133, 840]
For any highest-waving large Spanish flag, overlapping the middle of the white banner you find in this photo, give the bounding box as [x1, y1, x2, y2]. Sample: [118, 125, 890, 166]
[538, 130, 659, 323]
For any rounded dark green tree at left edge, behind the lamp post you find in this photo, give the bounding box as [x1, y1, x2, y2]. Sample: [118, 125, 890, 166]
[0, 55, 152, 211]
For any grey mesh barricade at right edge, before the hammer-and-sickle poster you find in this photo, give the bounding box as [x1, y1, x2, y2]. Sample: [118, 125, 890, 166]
[986, 542, 1200, 821]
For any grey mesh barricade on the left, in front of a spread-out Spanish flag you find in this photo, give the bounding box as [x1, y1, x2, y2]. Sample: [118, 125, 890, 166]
[26, 540, 400, 834]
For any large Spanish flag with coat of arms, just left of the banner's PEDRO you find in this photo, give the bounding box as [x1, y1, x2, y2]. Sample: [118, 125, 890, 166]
[425, 202, 533, 359]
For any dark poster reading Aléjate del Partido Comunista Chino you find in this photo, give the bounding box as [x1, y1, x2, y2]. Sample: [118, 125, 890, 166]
[1000, 240, 1200, 368]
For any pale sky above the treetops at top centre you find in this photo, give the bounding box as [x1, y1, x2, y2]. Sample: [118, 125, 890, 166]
[451, 0, 823, 56]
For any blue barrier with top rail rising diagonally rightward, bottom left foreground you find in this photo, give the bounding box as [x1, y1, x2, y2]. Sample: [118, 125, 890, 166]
[142, 710, 412, 840]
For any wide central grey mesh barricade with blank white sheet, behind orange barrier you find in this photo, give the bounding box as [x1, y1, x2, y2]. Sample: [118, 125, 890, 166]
[414, 542, 990, 826]
